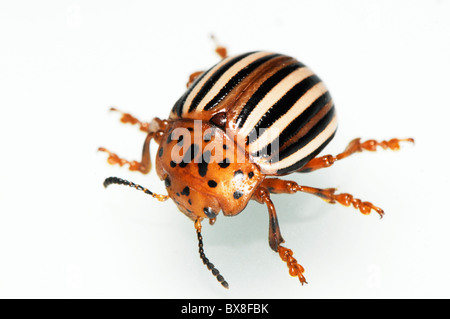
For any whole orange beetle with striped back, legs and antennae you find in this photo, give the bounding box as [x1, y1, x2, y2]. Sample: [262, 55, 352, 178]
[99, 40, 414, 288]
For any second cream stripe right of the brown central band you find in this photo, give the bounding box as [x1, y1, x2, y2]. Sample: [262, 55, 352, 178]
[249, 82, 327, 153]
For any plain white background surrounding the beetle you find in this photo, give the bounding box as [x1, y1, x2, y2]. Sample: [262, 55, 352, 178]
[0, 0, 450, 298]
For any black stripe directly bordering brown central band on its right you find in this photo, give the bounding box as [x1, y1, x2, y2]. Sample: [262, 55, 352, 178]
[236, 62, 304, 128]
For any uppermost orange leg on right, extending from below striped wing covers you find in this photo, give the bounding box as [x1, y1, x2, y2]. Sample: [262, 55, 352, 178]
[297, 138, 414, 173]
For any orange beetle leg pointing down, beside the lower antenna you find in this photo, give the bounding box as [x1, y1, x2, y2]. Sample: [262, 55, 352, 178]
[253, 187, 307, 285]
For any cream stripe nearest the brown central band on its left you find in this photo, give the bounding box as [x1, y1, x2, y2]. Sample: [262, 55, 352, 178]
[196, 52, 273, 112]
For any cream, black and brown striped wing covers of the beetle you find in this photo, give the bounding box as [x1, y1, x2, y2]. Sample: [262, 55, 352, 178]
[170, 52, 337, 175]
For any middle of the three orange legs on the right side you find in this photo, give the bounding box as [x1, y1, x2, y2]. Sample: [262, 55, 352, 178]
[261, 178, 384, 217]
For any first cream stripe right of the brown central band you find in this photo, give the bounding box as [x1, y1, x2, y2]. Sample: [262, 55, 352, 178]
[239, 67, 314, 136]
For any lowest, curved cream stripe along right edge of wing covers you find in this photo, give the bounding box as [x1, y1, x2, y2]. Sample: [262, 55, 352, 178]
[261, 115, 337, 173]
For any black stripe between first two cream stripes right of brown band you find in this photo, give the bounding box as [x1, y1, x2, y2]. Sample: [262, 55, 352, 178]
[247, 75, 320, 144]
